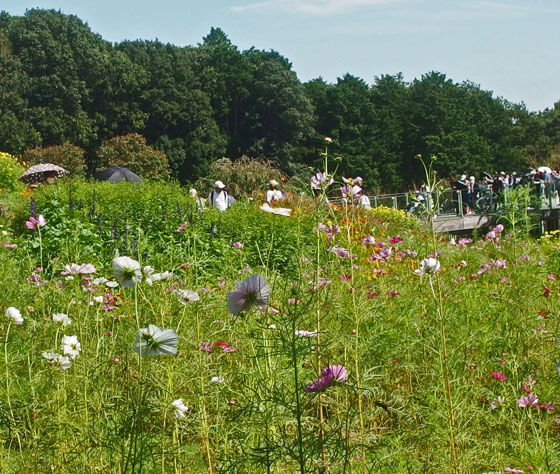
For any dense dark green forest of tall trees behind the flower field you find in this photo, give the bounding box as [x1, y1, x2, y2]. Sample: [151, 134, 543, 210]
[0, 9, 560, 191]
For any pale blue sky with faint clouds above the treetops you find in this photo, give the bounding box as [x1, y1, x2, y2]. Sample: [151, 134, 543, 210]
[0, 0, 560, 111]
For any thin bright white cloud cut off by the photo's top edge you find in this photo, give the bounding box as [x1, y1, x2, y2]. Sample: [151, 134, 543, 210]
[232, 0, 403, 16]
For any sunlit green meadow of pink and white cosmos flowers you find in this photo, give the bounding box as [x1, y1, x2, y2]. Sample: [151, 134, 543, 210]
[0, 180, 560, 473]
